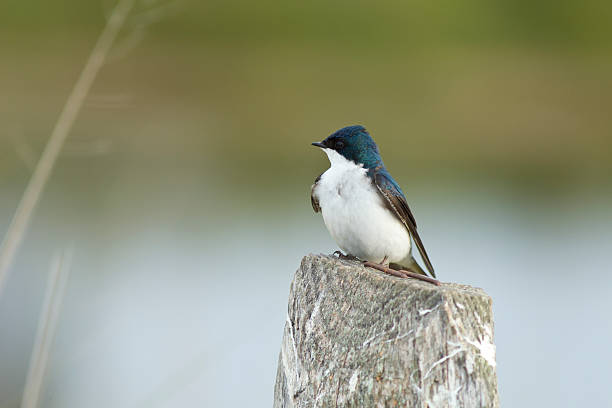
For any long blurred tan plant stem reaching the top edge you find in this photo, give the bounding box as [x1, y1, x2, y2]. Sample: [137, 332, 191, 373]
[0, 0, 135, 296]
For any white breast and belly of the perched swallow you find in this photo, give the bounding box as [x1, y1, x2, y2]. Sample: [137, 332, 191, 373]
[314, 149, 410, 262]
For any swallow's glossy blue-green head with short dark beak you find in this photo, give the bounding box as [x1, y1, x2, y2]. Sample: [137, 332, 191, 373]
[312, 125, 382, 169]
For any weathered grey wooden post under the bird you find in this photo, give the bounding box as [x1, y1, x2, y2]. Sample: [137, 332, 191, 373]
[274, 255, 499, 408]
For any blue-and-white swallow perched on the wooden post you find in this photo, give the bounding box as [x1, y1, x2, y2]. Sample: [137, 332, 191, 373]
[310, 125, 439, 285]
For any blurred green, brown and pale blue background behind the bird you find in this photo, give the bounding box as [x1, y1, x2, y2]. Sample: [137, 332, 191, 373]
[0, 0, 612, 407]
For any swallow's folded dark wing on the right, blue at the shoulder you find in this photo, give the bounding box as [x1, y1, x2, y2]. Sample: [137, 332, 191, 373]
[373, 170, 436, 278]
